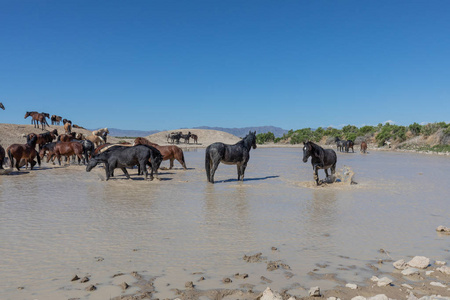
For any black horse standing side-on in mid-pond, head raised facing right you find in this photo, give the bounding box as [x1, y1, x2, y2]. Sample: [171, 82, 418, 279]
[205, 131, 256, 183]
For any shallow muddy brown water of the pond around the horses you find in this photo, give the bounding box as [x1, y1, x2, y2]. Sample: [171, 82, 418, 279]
[0, 148, 450, 299]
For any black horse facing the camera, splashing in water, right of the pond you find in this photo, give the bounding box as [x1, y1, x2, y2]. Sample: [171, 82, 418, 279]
[303, 142, 337, 185]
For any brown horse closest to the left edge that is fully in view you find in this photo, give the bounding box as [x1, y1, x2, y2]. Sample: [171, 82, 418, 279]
[6, 133, 41, 171]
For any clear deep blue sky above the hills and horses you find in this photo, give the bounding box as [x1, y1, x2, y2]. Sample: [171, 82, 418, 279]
[0, 0, 450, 130]
